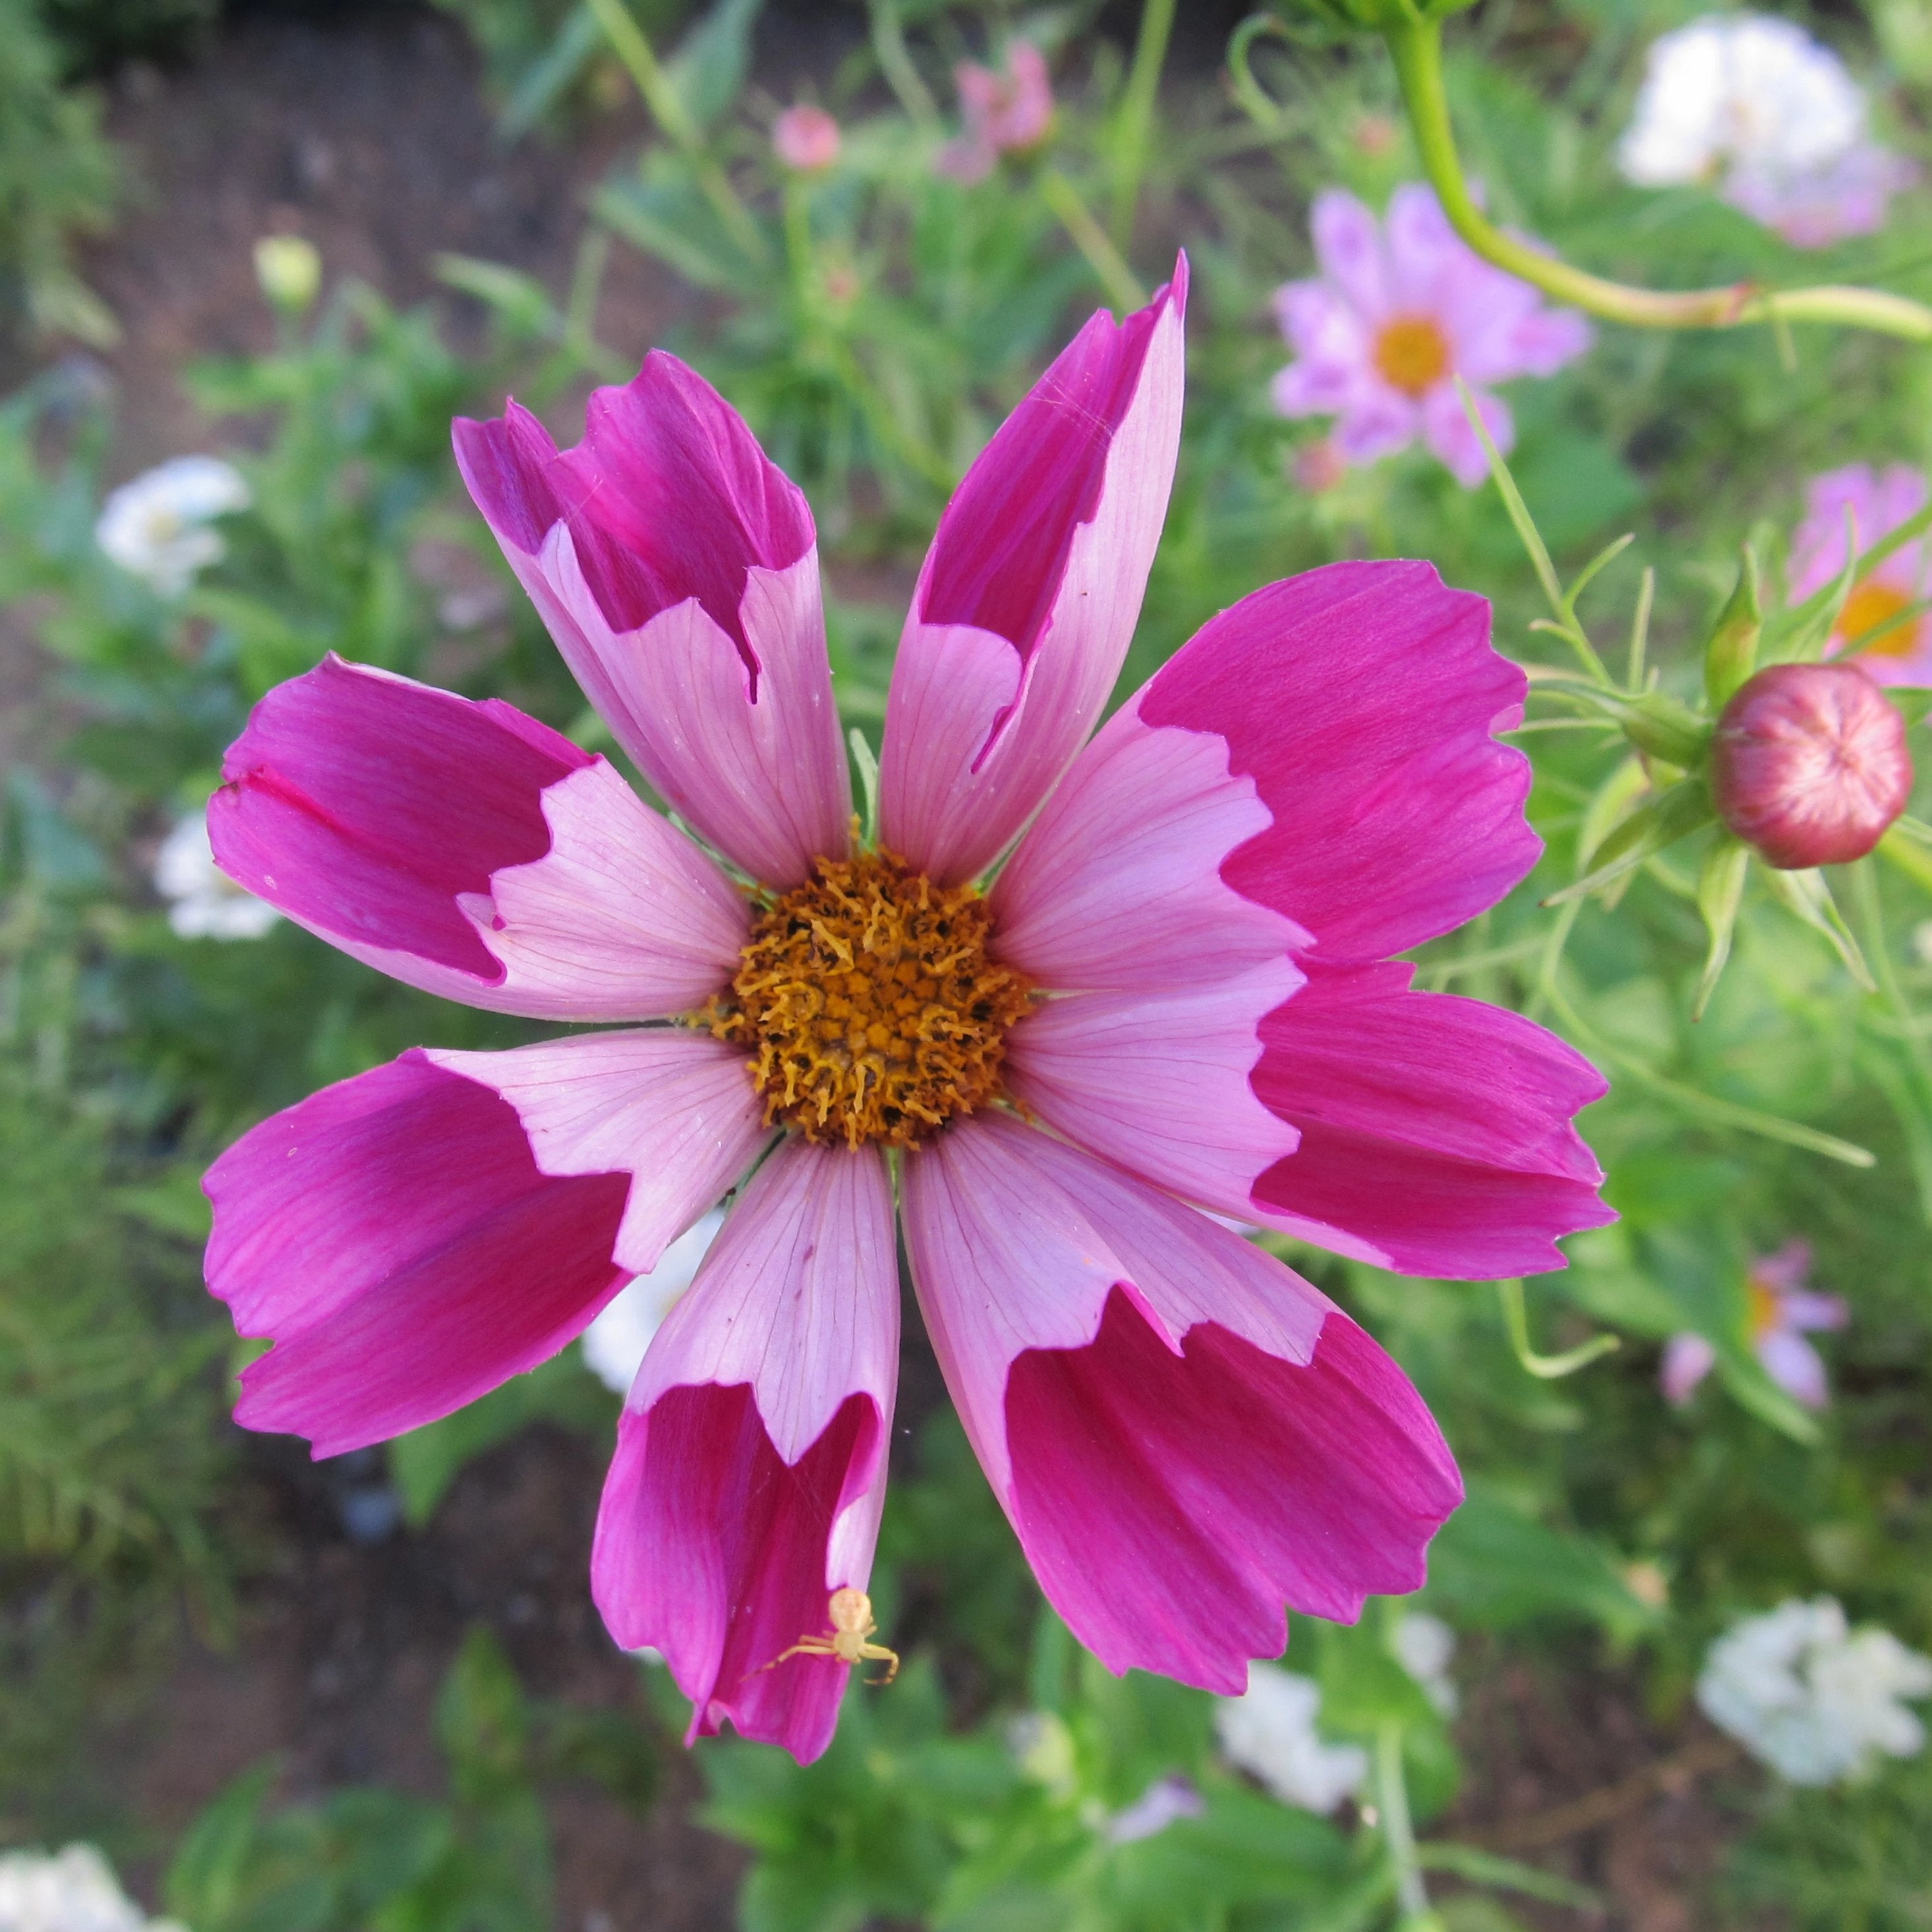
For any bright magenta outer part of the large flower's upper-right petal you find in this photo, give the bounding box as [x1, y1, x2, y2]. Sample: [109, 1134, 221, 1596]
[1138, 562, 1542, 960]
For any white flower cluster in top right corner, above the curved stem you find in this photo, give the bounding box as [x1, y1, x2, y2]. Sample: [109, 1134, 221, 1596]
[1617, 14, 1917, 247]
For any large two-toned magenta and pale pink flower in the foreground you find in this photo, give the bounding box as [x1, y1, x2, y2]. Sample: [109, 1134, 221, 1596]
[207, 261, 1607, 1758]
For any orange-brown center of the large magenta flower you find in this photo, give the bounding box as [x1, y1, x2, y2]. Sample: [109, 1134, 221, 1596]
[697, 852, 1032, 1148]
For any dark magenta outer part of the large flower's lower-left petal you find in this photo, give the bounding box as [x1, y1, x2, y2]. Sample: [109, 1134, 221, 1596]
[205, 1051, 633, 1457]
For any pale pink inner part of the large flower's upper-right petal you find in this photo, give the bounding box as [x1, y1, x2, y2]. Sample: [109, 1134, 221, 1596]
[991, 705, 1310, 993]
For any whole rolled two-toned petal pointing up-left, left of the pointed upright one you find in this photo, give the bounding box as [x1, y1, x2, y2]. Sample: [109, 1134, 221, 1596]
[456, 350, 852, 885]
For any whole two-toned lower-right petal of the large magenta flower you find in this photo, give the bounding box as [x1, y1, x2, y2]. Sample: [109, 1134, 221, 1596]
[904, 1115, 1463, 1692]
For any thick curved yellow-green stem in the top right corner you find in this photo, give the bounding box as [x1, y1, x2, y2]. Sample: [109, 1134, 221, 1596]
[1381, 15, 1932, 342]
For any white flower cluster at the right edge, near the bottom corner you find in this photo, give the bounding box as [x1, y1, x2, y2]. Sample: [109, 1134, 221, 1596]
[1696, 1596, 1932, 1785]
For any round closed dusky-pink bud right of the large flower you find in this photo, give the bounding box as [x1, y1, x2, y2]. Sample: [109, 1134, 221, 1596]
[1710, 665, 1913, 871]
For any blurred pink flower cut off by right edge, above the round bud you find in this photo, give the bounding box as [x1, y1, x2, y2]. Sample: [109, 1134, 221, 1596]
[1791, 464, 1932, 684]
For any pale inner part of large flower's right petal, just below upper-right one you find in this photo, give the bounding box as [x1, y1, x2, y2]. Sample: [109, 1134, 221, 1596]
[1007, 954, 1302, 1215]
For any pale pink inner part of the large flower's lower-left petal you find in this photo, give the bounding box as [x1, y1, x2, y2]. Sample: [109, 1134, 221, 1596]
[423, 1028, 771, 1275]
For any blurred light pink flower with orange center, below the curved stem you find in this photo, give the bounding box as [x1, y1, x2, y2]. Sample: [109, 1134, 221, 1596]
[1273, 182, 1590, 487]
